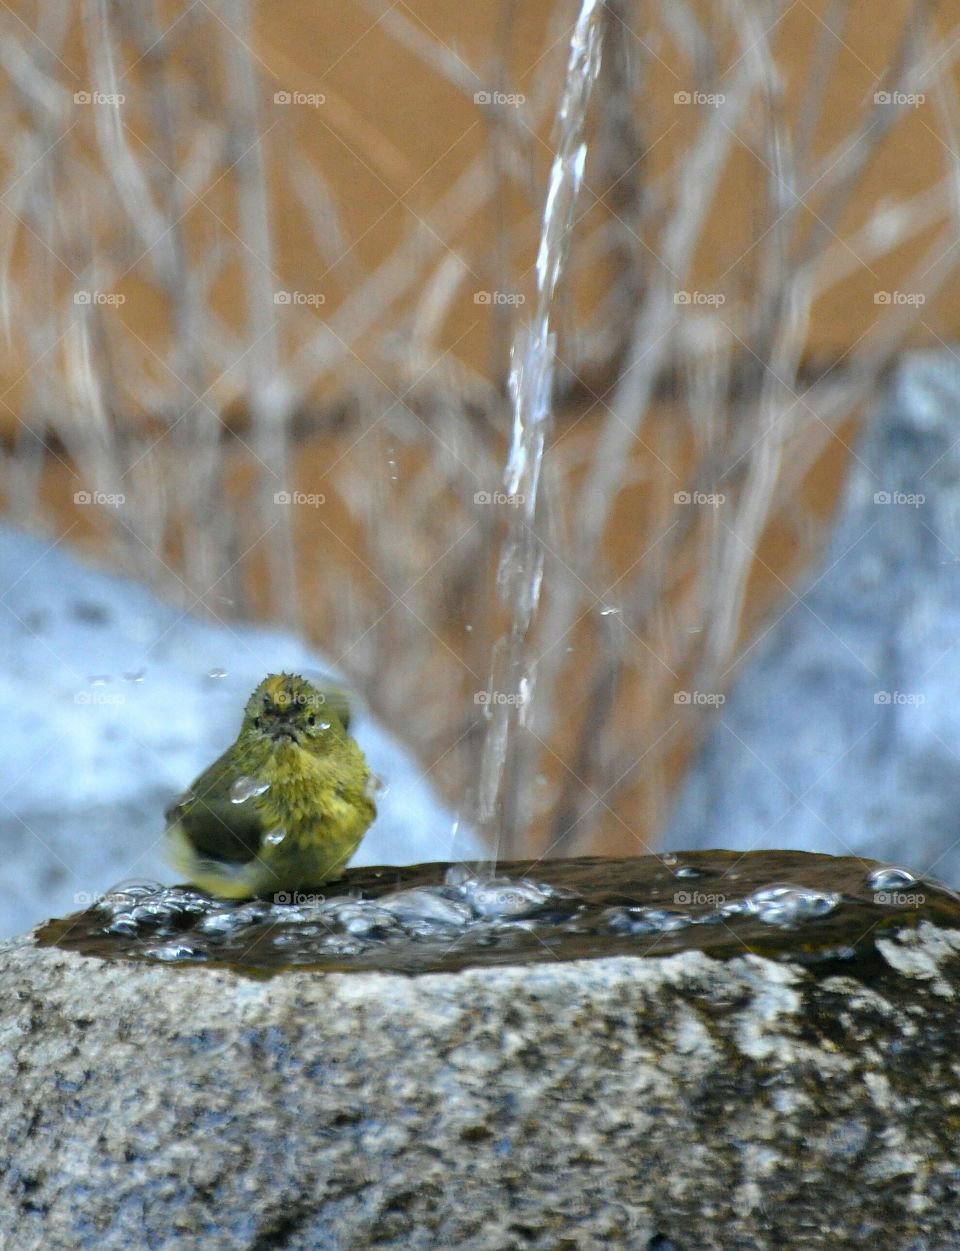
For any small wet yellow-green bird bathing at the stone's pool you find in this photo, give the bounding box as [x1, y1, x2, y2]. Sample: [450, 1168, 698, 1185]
[165, 673, 377, 899]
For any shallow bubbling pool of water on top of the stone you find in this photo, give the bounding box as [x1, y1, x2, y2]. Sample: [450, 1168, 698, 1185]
[38, 852, 960, 973]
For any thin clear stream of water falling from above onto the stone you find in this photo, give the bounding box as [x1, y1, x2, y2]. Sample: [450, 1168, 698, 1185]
[477, 0, 603, 861]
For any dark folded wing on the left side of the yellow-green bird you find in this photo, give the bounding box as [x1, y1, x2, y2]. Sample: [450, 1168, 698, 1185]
[166, 751, 263, 863]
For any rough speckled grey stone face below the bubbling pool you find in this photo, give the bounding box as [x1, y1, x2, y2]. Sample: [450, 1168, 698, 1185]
[0, 922, 960, 1251]
